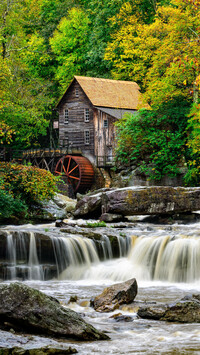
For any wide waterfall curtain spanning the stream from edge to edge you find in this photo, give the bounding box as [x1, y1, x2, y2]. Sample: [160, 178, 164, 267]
[0, 229, 200, 282]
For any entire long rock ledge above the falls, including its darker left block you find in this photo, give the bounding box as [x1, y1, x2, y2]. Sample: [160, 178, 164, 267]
[75, 186, 200, 218]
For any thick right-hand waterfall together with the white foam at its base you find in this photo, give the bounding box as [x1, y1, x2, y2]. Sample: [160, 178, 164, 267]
[85, 235, 200, 283]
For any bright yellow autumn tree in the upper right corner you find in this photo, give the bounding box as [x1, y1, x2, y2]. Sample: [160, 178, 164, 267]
[105, 0, 200, 107]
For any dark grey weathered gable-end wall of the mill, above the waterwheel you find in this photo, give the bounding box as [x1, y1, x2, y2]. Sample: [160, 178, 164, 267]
[59, 81, 94, 156]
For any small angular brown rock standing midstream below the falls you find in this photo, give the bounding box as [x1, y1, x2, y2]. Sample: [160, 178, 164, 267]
[91, 279, 137, 312]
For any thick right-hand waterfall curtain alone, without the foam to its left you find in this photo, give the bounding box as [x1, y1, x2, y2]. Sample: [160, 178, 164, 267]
[128, 236, 200, 282]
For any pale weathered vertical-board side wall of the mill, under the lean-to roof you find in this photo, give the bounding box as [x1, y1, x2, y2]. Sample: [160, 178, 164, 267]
[94, 109, 116, 157]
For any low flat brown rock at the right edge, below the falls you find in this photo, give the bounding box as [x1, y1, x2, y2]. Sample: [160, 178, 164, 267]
[138, 294, 200, 323]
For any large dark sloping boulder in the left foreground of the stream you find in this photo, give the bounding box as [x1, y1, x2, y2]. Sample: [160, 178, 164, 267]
[0, 282, 108, 340]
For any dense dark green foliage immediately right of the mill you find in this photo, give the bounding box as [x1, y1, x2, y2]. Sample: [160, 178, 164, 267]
[116, 98, 188, 180]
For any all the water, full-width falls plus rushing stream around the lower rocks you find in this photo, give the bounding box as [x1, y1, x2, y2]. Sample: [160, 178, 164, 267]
[0, 223, 200, 355]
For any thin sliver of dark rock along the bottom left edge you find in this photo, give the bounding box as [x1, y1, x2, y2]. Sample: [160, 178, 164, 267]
[0, 346, 77, 355]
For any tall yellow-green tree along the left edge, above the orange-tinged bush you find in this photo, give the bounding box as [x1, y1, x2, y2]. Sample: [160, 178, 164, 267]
[0, 0, 52, 148]
